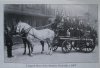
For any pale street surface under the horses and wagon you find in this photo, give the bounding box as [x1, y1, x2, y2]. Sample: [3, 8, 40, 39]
[4, 44, 99, 64]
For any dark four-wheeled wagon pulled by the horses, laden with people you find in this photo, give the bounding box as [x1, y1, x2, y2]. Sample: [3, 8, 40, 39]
[53, 29, 95, 53]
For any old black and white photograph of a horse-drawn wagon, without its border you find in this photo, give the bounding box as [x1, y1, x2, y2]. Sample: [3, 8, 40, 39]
[3, 4, 99, 64]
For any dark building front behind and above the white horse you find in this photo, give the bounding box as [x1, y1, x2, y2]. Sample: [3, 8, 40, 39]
[4, 4, 54, 27]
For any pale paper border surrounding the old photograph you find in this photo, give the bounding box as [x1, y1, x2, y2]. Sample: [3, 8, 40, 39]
[0, 0, 100, 68]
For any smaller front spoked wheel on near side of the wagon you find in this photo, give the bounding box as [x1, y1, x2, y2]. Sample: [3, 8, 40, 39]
[62, 40, 72, 53]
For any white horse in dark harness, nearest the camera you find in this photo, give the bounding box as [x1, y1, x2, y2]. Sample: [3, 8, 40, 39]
[16, 22, 55, 55]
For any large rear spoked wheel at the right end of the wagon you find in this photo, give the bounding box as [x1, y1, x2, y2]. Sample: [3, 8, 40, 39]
[81, 40, 95, 53]
